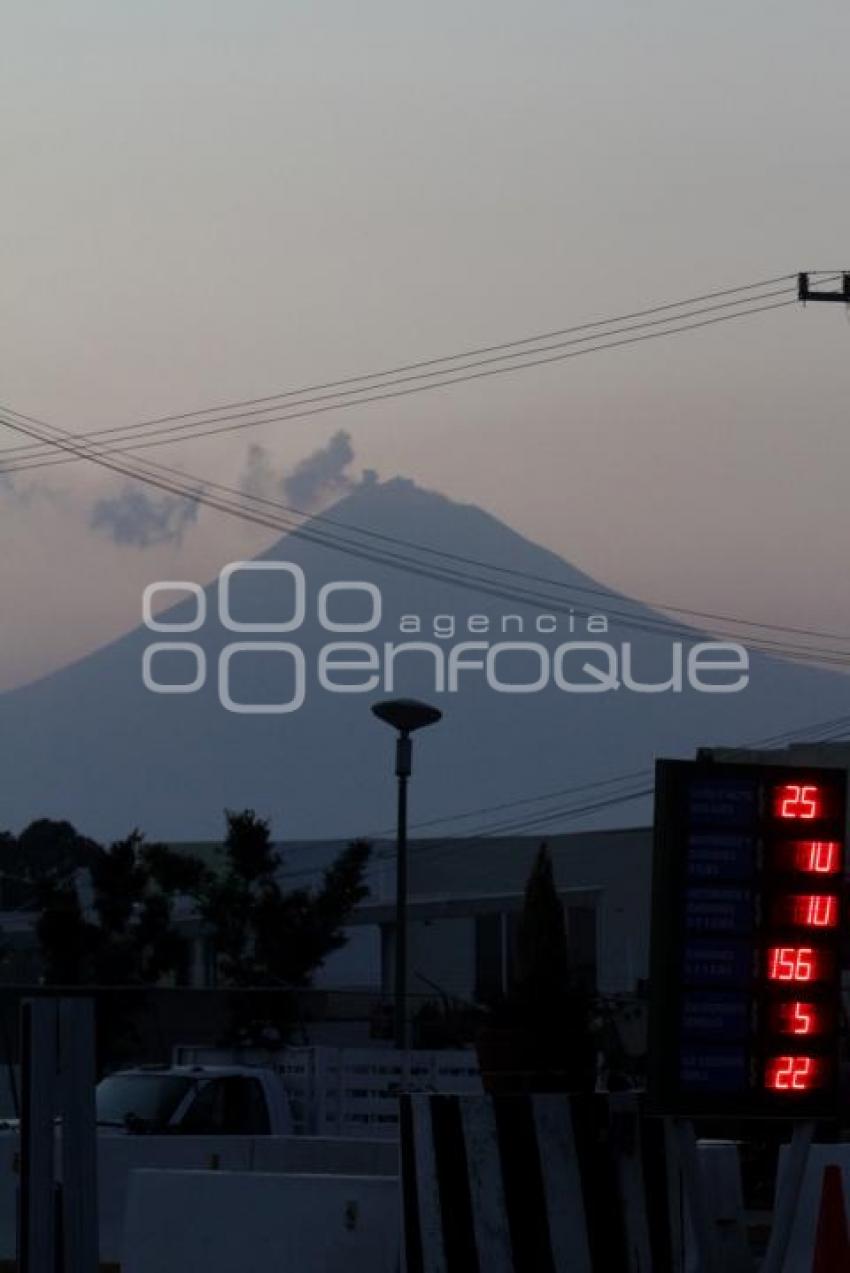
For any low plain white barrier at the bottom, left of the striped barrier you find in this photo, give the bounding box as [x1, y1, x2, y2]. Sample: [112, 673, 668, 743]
[121, 1171, 400, 1273]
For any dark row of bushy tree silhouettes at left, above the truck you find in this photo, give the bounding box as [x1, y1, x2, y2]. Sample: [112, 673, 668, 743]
[0, 810, 369, 988]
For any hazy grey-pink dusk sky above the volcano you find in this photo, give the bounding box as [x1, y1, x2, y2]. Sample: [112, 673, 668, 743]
[0, 0, 850, 687]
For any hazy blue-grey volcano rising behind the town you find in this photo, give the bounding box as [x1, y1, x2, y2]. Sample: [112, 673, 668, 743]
[0, 479, 850, 840]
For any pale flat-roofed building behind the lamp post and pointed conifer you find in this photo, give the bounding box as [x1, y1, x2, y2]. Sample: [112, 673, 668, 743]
[341, 827, 651, 1002]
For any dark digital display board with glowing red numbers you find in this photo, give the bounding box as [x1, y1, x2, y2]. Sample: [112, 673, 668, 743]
[649, 760, 846, 1118]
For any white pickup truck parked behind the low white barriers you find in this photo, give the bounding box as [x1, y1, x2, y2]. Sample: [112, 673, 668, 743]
[97, 1066, 293, 1136]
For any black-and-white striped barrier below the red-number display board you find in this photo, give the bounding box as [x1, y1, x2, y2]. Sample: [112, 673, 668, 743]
[401, 1092, 752, 1273]
